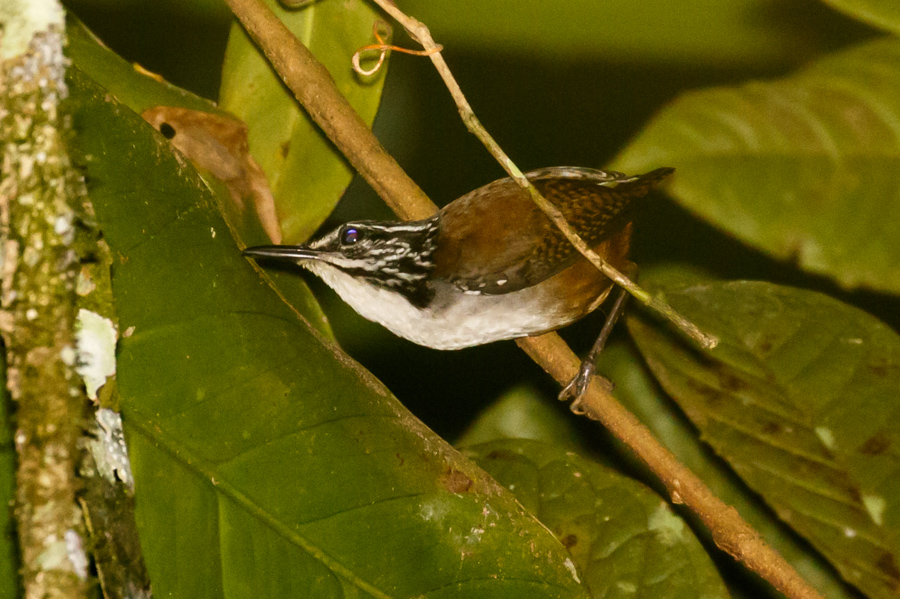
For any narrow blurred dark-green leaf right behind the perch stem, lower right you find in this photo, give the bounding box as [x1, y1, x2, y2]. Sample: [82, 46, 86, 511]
[597, 344, 858, 599]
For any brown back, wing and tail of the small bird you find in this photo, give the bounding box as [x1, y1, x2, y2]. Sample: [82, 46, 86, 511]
[434, 167, 673, 295]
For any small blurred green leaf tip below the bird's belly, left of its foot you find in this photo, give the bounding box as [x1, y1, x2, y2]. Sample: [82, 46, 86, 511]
[456, 386, 582, 451]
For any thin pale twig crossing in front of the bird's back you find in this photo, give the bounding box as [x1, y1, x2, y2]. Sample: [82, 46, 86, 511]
[362, 0, 719, 349]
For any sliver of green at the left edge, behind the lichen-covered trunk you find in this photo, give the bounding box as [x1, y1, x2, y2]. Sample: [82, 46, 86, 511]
[0, 352, 19, 599]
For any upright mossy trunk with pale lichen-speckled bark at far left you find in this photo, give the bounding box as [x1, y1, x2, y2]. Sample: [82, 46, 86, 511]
[0, 7, 88, 599]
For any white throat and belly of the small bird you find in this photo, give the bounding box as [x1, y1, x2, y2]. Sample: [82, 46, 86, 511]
[306, 263, 606, 349]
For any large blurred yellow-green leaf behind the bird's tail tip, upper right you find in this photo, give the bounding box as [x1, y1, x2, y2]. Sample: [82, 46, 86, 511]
[614, 39, 900, 293]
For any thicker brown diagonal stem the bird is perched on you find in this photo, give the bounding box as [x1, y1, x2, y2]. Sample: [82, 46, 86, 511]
[226, 0, 821, 599]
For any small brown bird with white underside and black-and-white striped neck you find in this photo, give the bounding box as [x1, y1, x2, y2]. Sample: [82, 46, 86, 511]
[243, 167, 674, 398]
